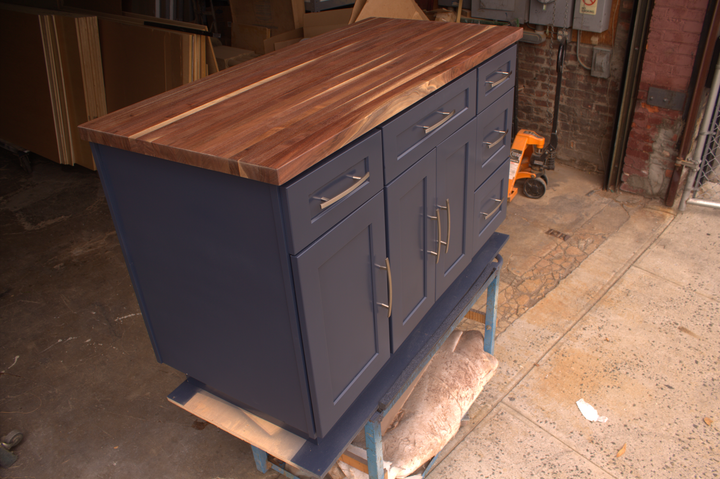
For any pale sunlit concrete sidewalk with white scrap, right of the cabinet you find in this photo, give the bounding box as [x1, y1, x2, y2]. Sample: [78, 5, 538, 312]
[429, 168, 720, 479]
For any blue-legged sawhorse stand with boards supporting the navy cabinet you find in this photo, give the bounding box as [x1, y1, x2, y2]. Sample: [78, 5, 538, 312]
[168, 238, 508, 479]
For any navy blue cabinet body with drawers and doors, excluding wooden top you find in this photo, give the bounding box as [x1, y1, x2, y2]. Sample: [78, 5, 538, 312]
[88, 45, 515, 440]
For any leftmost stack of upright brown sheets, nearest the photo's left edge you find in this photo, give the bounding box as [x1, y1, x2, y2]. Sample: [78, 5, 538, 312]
[0, 5, 107, 169]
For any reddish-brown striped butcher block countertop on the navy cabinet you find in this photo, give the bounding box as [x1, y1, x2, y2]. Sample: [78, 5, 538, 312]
[80, 18, 522, 185]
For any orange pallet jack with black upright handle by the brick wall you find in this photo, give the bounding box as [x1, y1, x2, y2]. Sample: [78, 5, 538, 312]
[508, 37, 567, 202]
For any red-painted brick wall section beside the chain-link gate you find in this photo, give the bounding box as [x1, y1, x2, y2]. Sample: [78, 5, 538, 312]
[620, 0, 707, 197]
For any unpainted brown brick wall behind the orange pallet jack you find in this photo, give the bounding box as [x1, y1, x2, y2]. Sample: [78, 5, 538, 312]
[516, 0, 633, 172]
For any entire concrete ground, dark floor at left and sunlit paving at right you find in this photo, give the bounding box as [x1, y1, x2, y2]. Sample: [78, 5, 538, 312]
[0, 153, 720, 479]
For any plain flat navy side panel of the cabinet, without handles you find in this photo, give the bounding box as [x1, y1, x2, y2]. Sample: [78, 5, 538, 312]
[94, 145, 314, 436]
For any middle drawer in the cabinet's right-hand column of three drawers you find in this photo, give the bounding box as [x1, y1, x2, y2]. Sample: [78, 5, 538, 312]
[474, 89, 515, 188]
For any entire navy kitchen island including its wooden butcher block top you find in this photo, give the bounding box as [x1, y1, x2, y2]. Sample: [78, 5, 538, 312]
[81, 19, 522, 473]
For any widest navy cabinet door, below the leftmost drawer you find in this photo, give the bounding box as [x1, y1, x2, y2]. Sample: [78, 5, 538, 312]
[292, 193, 390, 437]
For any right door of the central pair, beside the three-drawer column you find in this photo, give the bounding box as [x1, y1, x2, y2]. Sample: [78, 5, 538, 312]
[435, 119, 477, 297]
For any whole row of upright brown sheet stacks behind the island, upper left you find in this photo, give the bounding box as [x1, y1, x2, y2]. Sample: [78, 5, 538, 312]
[0, 4, 218, 170]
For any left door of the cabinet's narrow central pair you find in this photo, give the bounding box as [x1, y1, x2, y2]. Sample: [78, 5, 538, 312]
[385, 150, 440, 352]
